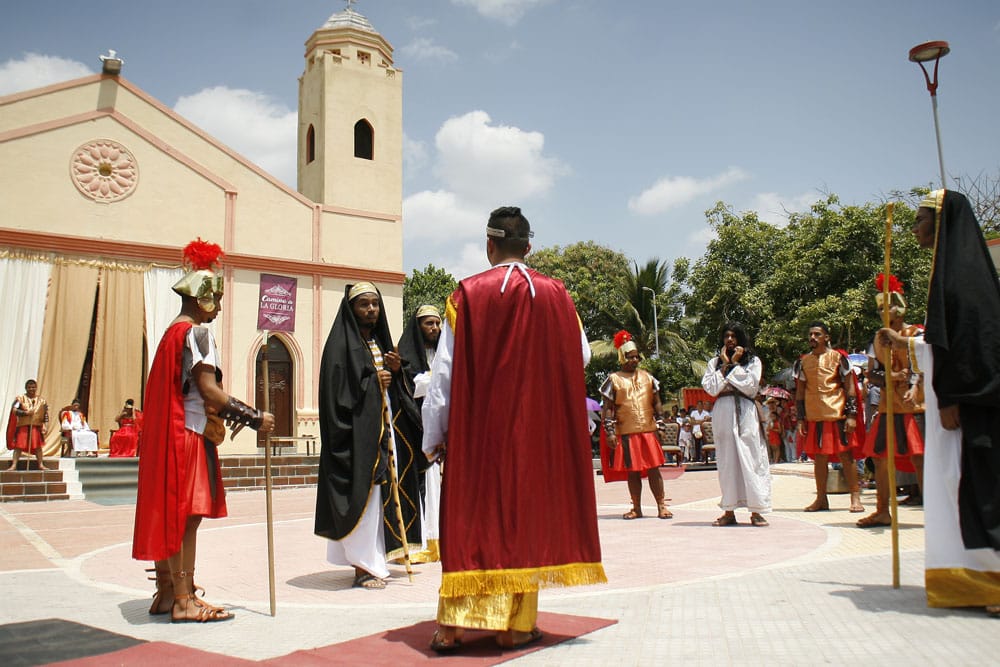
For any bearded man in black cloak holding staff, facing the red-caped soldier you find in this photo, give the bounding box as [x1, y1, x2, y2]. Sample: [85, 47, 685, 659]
[315, 283, 427, 589]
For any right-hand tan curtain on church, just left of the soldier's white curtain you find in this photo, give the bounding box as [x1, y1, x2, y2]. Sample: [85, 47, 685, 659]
[87, 268, 145, 444]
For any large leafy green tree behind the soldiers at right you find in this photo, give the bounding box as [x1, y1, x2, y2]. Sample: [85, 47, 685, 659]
[688, 195, 930, 380]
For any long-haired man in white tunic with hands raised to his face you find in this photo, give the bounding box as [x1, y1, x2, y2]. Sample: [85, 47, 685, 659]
[701, 322, 771, 526]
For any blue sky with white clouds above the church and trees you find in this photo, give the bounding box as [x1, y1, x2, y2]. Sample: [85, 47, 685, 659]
[0, 0, 1000, 277]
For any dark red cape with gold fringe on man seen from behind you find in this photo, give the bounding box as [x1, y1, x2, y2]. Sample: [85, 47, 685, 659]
[440, 267, 604, 596]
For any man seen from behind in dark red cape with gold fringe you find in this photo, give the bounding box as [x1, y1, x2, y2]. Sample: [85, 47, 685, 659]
[423, 207, 606, 652]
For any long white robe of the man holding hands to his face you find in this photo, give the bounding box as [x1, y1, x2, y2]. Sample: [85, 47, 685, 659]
[701, 357, 771, 512]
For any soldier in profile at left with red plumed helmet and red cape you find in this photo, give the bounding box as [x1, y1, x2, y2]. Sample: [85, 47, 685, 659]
[132, 238, 274, 623]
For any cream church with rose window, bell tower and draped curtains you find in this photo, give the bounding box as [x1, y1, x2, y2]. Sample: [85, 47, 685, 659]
[0, 8, 404, 456]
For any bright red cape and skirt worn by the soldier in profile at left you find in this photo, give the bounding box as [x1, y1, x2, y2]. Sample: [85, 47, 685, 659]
[132, 322, 226, 560]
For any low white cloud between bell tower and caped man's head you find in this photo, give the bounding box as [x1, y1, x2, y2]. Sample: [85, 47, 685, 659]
[403, 190, 488, 243]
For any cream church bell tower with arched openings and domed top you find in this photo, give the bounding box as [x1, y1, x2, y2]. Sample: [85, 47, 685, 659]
[298, 0, 403, 216]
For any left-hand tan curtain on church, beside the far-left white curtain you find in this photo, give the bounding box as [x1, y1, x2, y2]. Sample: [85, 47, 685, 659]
[38, 263, 98, 456]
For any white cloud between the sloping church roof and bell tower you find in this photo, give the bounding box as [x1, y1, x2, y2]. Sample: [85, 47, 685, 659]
[174, 86, 298, 188]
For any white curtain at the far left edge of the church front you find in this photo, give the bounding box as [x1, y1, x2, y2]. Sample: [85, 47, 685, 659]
[0, 253, 54, 458]
